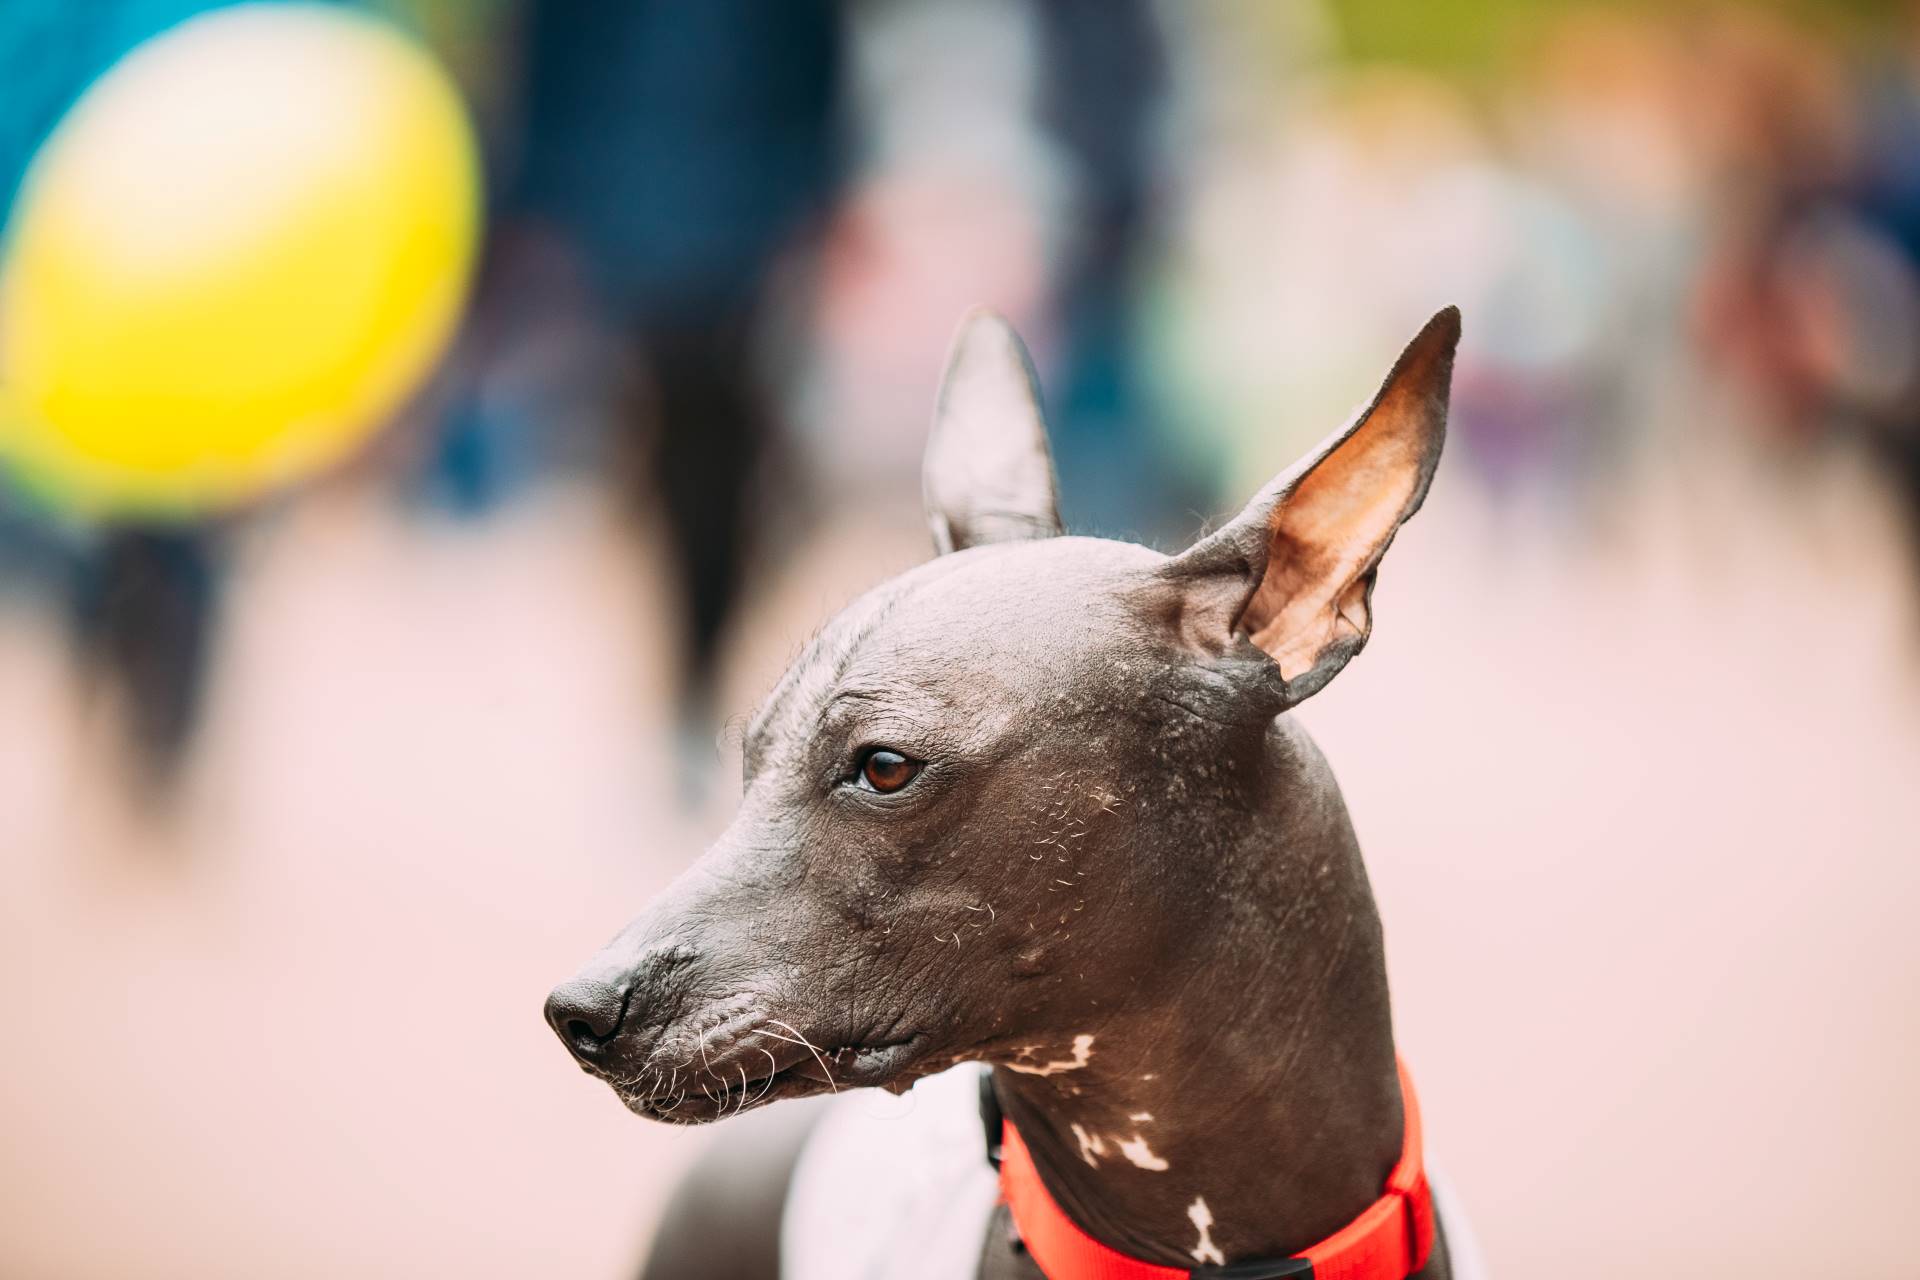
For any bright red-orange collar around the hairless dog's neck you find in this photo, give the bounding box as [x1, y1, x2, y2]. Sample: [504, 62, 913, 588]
[1000, 1063, 1434, 1280]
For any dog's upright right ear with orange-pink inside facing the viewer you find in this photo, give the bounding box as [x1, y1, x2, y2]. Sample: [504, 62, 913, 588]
[1167, 307, 1459, 706]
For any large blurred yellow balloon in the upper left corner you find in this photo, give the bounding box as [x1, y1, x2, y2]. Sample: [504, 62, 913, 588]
[0, 4, 478, 516]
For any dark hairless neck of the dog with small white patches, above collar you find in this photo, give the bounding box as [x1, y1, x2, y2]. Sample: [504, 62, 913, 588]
[995, 722, 1404, 1267]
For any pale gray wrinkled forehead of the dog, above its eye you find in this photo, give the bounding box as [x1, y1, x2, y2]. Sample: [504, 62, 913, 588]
[745, 537, 1164, 766]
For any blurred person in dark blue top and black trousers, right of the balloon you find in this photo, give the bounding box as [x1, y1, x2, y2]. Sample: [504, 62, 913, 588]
[442, 0, 843, 733]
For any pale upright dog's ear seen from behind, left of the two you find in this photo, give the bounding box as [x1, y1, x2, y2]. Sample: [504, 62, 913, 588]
[922, 309, 1060, 555]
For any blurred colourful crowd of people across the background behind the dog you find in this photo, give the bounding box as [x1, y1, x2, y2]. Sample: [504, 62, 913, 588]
[11, 0, 1920, 777]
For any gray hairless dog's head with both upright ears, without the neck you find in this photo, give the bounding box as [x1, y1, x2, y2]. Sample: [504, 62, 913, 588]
[547, 309, 1459, 1121]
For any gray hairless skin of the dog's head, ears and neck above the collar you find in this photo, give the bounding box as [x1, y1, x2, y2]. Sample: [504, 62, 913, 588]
[547, 309, 1459, 1280]
